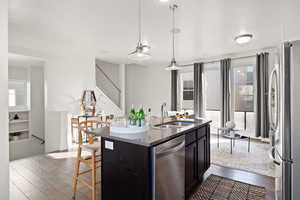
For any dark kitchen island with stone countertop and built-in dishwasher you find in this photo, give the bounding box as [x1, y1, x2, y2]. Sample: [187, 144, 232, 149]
[88, 119, 211, 200]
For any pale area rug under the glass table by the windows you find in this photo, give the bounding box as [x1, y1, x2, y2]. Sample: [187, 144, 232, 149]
[211, 135, 275, 177]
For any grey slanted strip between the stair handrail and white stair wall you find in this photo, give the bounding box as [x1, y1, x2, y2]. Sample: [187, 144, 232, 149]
[96, 64, 121, 107]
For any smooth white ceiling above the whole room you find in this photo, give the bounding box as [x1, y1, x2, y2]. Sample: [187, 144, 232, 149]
[9, 0, 300, 64]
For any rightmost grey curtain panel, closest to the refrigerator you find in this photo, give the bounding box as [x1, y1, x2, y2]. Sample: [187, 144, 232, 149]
[255, 53, 269, 138]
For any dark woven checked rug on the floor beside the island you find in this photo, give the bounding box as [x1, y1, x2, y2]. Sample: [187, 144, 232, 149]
[190, 175, 266, 200]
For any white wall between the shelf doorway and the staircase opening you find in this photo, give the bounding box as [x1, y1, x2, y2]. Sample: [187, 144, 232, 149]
[45, 53, 120, 152]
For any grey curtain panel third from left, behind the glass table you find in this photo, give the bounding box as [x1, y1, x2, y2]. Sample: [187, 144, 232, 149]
[220, 58, 231, 127]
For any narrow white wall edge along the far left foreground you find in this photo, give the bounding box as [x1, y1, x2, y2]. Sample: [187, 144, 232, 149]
[0, 0, 9, 200]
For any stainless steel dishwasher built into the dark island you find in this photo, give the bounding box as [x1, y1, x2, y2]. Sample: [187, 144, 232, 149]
[152, 135, 185, 200]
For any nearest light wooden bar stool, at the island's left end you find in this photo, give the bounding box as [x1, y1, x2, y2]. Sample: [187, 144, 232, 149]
[72, 120, 110, 200]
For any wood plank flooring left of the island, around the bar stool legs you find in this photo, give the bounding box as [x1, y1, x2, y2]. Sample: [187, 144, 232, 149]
[10, 153, 100, 200]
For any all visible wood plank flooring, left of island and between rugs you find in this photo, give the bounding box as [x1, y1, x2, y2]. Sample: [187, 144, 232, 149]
[10, 152, 274, 200]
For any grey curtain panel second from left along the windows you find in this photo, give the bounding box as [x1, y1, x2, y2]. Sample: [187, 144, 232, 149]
[194, 63, 204, 117]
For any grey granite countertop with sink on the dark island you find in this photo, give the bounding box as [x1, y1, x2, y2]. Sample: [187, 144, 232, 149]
[86, 119, 211, 147]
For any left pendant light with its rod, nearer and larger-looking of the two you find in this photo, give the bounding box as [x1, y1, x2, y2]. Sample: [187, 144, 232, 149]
[128, 0, 151, 61]
